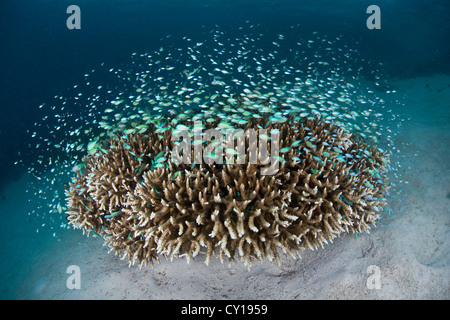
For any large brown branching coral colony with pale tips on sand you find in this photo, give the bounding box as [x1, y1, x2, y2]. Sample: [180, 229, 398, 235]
[67, 116, 387, 264]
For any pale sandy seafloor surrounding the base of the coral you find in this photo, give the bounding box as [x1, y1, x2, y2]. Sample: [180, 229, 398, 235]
[0, 75, 450, 299]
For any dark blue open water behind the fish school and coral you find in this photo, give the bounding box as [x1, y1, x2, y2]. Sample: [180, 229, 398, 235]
[0, 0, 450, 190]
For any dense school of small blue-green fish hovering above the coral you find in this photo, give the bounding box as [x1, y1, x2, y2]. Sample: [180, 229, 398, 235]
[17, 22, 402, 236]
